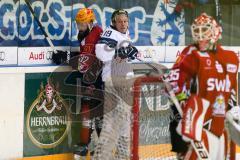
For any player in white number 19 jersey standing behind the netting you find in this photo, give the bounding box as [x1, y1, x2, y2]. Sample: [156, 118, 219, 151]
[94, 10, 138, 160]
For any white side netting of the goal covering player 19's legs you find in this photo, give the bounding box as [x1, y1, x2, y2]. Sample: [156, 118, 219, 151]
[93, 76, 132, 160]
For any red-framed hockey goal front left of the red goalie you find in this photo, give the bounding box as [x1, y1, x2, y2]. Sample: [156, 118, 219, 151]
[130, 77, 236, 160]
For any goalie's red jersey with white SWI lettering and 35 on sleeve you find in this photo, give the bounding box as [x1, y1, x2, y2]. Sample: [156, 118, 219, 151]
[170, 45, 239, 136]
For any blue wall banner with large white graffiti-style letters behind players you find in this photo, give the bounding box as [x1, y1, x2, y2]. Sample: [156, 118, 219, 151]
[0, 0, 185, 47]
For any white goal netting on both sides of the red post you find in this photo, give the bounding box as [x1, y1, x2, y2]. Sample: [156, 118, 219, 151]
[93, 78, 176, 160]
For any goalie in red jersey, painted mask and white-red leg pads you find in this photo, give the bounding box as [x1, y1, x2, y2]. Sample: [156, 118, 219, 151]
[168, 13, 240, 160]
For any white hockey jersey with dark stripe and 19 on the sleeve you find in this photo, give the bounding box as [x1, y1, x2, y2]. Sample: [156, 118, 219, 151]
[95, 27, 133, 81]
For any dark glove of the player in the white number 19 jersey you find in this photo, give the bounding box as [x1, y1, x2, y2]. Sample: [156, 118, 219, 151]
[115, 45, 138, 60]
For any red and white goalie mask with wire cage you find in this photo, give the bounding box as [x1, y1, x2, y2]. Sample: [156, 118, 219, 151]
[191, 13, 222, 50]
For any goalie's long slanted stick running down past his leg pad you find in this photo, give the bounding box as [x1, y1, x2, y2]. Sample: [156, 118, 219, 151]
[136, 54, 210, 160]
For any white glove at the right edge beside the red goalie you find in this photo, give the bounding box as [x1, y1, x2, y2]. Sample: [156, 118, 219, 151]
[225, 106, 240, 146]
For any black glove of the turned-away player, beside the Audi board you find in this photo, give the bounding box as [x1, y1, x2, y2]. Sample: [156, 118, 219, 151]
[52, 50, 78, 65]
